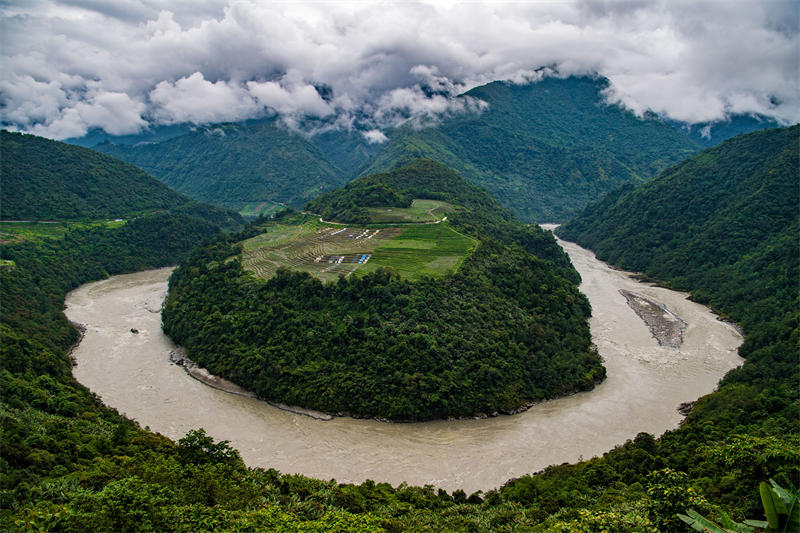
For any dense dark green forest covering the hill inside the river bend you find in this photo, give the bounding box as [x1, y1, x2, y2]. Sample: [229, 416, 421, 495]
[163, 160, 605, 420]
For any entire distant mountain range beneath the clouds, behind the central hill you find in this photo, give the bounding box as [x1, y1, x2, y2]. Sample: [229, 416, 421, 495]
[84, 77, 774, 222]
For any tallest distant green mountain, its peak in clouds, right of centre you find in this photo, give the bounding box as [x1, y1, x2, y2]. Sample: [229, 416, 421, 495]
[365, 77, 697, 221]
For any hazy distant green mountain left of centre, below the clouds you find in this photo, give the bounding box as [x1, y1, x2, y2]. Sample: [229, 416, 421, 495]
[95, 120, 347, 210]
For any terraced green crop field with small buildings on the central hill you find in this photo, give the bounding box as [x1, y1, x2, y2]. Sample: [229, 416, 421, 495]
[242, 219, 476, 281]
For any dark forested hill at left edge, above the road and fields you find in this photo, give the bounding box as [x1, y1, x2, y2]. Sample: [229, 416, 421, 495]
[0, 130, 183, 220]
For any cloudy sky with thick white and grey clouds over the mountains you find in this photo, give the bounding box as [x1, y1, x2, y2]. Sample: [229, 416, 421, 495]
[0, 0, 800, 142]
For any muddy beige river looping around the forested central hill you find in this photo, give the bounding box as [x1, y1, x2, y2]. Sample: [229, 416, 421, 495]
[66, 231, 742, 494]
